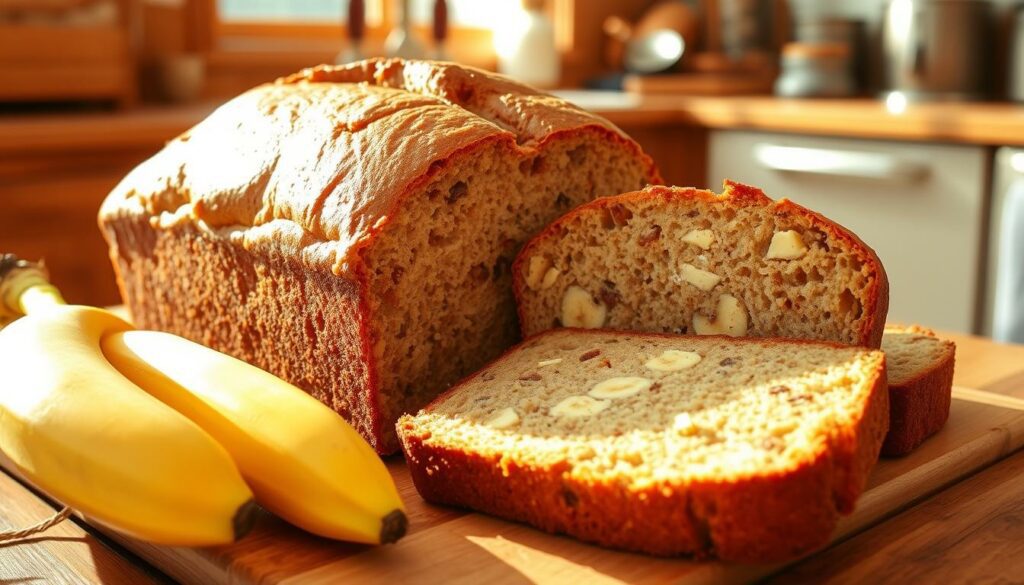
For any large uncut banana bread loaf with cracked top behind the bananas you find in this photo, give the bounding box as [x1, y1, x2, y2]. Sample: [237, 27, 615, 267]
[99, 59, 659, 453]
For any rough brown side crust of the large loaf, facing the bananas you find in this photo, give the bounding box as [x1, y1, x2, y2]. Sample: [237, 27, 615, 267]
[104, 221, 393, 452]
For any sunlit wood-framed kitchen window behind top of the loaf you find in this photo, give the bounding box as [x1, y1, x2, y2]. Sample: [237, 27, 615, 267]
[182, 0, 577, 97]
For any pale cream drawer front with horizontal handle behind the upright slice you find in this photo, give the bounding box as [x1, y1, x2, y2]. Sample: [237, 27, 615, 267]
[708, 130, 990, 333]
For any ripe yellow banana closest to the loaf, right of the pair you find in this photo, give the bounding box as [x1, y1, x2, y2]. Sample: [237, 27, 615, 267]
[102, 331, 407, 544]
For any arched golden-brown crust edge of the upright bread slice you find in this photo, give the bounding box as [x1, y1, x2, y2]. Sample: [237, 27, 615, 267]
[512, 180, 889, 348]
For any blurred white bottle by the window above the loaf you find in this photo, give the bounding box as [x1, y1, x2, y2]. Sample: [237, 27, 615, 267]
[495, 0, 561, 87]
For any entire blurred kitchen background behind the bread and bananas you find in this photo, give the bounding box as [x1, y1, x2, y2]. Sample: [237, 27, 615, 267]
[0, 0, 1024, 342]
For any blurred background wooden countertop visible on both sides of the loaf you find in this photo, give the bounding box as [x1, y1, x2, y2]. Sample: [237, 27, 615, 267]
[6, 91, 1024, 155]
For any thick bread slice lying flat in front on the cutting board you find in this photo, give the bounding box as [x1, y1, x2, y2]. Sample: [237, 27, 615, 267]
[398, 329, 889, 561]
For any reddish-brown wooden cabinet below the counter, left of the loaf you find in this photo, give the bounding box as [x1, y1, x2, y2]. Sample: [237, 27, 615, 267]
[0, 106, 205, 304]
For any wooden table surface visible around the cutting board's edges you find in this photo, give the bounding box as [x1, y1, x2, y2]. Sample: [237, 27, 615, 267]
[6, 335, 1024, 583]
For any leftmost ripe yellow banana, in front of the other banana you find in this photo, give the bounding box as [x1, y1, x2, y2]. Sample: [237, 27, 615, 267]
[0, 305, 255, 546]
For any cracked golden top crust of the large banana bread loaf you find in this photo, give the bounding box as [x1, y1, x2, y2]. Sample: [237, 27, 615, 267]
[100, 59, 657, 274]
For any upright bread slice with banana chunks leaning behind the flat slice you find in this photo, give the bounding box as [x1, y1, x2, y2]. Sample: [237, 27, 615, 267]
[513, 181, 889, 347]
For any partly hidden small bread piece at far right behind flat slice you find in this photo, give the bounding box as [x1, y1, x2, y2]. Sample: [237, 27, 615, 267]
[882, 325, 956, 457]
